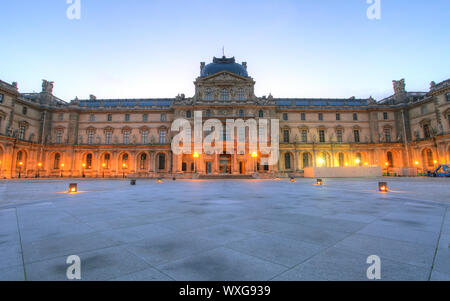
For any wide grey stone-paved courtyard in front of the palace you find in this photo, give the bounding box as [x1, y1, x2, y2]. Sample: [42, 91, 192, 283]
[0, 178, 450, 281]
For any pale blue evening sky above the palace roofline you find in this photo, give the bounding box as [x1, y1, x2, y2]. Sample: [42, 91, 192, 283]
[0, 0, 450, 101]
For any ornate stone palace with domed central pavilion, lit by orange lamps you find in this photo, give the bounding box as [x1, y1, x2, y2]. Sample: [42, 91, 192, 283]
[0, 57, 450, 178]
